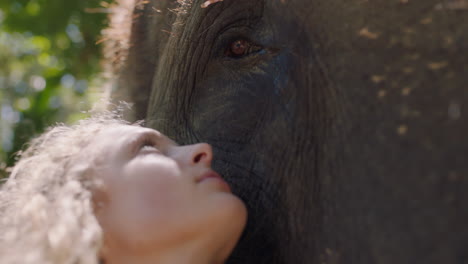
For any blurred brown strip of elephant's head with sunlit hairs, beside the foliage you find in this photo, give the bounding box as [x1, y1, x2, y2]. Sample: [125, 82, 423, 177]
[103, 0, 180, 120]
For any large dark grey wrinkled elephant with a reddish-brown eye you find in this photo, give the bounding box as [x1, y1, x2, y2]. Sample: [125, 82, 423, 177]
[105, 0, 468, 264]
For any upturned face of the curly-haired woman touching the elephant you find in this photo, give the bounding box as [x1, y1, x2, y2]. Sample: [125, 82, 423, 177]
[91, 125, 247, 252]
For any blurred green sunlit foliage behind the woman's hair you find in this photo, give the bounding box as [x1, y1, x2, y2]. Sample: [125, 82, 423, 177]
[0, 0, 111, 177]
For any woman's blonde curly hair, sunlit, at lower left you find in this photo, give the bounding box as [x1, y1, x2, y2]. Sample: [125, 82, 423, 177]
[0, 112, 132, 264]
